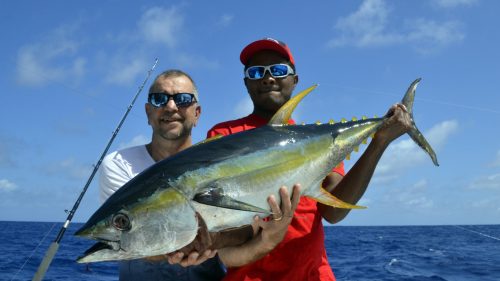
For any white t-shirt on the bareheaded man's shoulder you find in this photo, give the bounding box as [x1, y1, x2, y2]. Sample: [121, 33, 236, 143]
[99, 145, 155, 203]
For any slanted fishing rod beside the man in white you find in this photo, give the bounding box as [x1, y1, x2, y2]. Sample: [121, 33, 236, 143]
[32, 59, 158, 281]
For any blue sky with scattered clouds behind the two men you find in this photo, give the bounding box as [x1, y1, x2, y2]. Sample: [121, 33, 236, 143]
[0, 0, 500, 225]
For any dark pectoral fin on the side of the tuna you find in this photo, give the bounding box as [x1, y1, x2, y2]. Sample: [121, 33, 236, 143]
[193, 188, 272, 215]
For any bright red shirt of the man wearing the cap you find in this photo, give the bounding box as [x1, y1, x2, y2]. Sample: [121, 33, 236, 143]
[207, 114, 344, 281]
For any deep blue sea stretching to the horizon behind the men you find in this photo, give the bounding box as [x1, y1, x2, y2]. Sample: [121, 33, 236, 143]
[0, 222, 500, 281]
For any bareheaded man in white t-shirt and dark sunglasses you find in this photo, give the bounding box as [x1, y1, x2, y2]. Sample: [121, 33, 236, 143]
[99, 70, 224, 281]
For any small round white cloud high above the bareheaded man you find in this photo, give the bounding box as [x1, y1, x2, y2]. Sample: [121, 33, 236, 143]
[138, 7, 184, 48]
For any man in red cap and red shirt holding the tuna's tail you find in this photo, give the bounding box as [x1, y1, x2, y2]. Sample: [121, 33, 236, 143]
[207, 38, 416, 280]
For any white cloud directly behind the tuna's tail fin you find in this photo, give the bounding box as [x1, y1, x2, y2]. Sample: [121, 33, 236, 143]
[373, 120, 458, 179]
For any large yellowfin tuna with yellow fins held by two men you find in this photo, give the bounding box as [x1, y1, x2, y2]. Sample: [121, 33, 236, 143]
[75, 79, 438, 263]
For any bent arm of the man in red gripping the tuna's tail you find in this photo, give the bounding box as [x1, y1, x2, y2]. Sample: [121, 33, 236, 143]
[318, 104, 411, 223]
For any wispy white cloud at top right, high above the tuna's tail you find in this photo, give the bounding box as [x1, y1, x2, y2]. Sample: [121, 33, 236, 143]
[327, 0, 465, 53]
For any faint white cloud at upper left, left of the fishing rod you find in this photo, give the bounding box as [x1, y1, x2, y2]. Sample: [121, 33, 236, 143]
[16, 26, 86, 86]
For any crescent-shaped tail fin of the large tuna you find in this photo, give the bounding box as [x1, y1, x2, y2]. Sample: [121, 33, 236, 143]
[401, 78, 439, 166]
